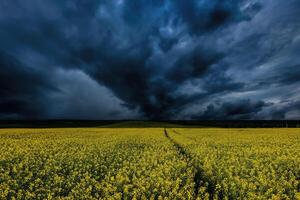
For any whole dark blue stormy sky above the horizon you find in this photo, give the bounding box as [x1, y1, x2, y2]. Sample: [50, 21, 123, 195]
[0, 0, 300, 119]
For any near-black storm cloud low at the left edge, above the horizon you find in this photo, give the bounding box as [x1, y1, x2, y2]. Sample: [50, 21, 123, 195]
[0, 52, 56, 119]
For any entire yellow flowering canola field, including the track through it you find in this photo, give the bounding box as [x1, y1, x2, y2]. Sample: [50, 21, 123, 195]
[0, 127, 300, 199]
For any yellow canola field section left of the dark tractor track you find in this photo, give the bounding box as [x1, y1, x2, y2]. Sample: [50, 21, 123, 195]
[0, 128, 194, 199]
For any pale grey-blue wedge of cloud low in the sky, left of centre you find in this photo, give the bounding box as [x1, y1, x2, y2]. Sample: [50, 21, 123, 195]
[48, 70, 140, 120]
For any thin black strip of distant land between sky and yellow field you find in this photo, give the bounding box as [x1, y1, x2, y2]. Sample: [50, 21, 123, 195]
[0, 120, 300, 128]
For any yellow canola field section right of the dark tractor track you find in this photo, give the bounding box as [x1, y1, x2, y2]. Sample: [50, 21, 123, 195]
[169, 128, 300, 200]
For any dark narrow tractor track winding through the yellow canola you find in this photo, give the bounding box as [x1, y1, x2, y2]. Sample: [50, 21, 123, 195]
[164, 129, 206, 199]
